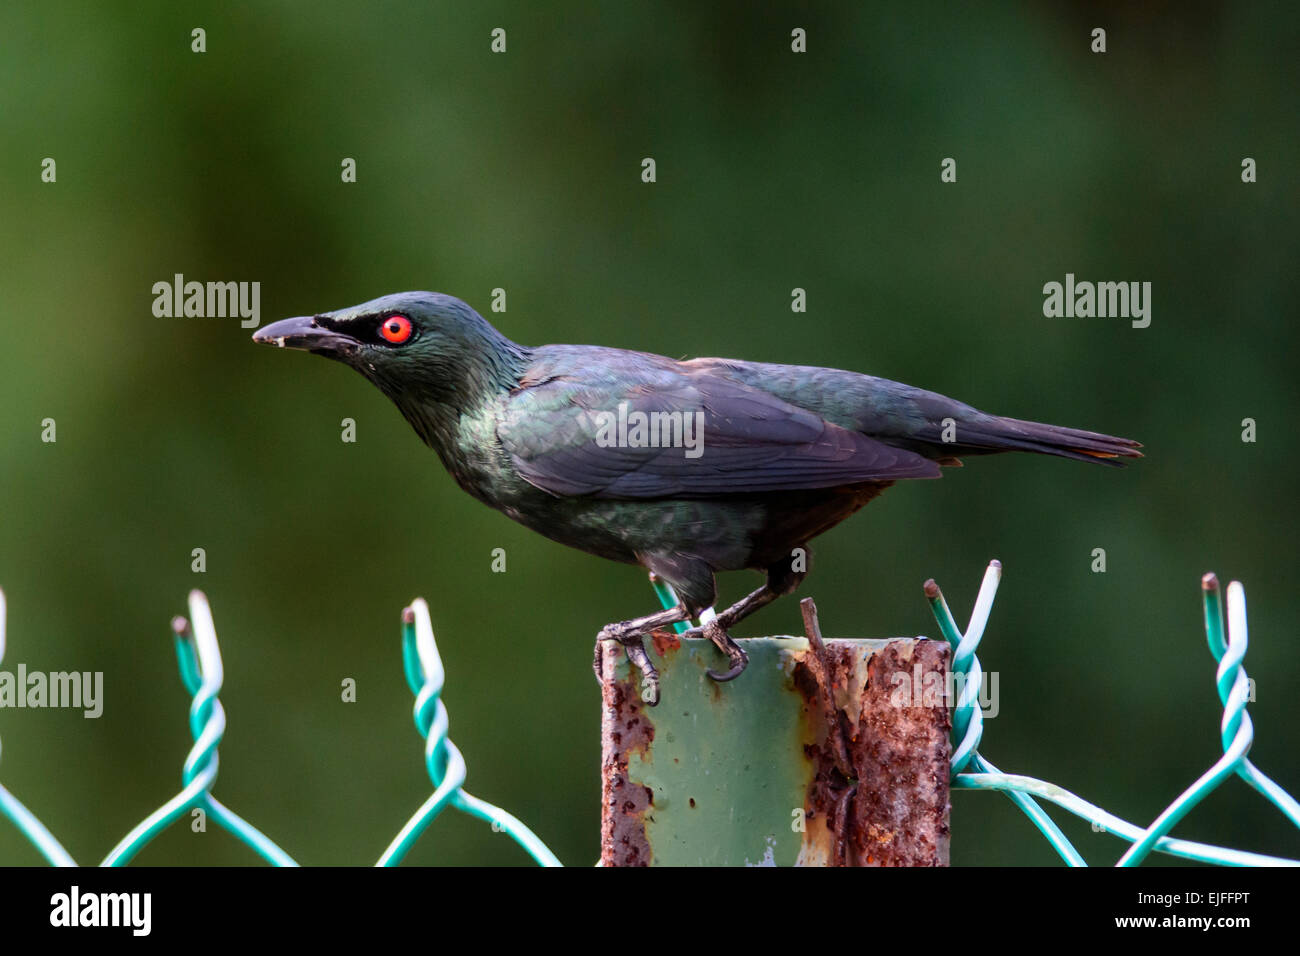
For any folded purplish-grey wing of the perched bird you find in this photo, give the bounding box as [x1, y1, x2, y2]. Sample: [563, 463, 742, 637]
[497, 356, 939, 498]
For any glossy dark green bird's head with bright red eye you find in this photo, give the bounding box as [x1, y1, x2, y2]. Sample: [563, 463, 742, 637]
[252, 293, 528, 441]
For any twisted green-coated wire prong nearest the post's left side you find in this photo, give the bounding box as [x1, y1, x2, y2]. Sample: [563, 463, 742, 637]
[376, 598, 560, 866]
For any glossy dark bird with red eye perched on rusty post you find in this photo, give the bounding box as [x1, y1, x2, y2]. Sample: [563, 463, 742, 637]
[252, 291, 1141, 706]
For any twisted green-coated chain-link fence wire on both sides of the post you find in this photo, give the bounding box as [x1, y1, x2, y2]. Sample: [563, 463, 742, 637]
[0, 561, 1300, 866]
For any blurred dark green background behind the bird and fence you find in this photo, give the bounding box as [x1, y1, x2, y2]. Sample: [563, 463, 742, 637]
[0, 3, 1300, 864]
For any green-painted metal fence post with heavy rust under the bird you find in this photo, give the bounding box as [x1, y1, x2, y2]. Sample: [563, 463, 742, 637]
[601, 598, 952, 866]
